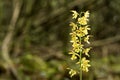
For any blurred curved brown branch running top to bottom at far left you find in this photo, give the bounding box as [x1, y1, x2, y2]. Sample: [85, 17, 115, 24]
[2, 0, 22, 80]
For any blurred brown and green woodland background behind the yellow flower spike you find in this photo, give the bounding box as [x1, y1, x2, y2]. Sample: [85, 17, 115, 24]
[0, 0, 120, 80]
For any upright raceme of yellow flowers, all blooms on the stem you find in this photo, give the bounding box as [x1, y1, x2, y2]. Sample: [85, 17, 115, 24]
[68, 10, 91, 77]
